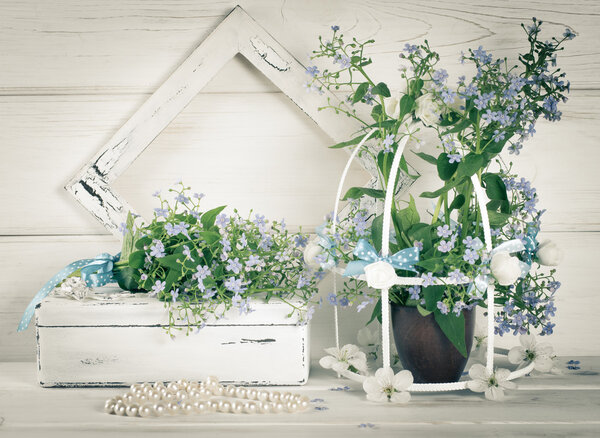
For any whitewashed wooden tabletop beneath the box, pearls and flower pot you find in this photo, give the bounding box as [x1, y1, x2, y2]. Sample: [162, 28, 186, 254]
[0, 357, 600, 438]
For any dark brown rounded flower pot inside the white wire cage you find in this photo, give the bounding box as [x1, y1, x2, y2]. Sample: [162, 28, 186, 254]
[392, 304, 475, 383]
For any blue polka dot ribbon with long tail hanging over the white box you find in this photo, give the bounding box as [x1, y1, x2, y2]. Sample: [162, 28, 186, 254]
[17, 253, 121, 332]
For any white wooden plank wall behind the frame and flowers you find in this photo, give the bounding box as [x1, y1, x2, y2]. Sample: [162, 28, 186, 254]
[0, 0, 600, 361]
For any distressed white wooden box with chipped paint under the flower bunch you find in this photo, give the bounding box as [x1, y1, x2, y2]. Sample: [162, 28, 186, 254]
[35, 287, 310, 387]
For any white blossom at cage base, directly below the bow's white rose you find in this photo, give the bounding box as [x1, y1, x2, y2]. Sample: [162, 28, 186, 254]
[363, 367, 413, 403]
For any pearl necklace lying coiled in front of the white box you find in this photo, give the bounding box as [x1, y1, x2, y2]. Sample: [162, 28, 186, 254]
[104, 376, 309, 417]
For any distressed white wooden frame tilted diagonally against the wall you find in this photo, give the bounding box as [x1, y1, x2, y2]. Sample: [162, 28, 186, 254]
[65, 6, 412, 236]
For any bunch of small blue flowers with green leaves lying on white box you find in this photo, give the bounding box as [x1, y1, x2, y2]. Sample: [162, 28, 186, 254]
[115, 183, 322, 334]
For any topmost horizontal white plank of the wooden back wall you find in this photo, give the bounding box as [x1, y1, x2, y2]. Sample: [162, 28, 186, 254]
[0, 0, 600, 94]
